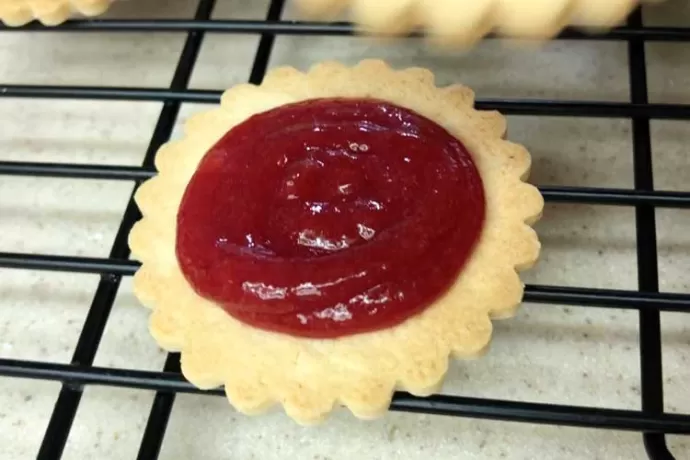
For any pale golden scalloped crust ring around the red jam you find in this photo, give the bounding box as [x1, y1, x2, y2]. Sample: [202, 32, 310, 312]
[129, 60, 543, 424]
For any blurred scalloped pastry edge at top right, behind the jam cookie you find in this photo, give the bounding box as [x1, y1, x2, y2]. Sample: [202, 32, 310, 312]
[295, 0, 663, 45]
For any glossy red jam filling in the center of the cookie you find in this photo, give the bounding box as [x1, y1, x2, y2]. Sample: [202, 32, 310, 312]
[176, 99, 485, 338]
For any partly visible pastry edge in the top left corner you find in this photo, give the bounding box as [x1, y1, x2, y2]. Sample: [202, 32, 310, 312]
[0, 0, 114, 27]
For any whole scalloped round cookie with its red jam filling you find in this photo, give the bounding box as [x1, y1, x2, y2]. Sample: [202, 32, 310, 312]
[129, 60, 543, 425]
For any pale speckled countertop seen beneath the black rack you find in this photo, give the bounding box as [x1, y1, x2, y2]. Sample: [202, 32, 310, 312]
[0, 0, 690, 460]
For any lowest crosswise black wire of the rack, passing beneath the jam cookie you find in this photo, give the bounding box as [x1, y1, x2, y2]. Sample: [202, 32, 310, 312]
[0, 356, 690, 436]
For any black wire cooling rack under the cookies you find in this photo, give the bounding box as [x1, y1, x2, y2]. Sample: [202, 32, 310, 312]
[0, 0, 690, 460]
